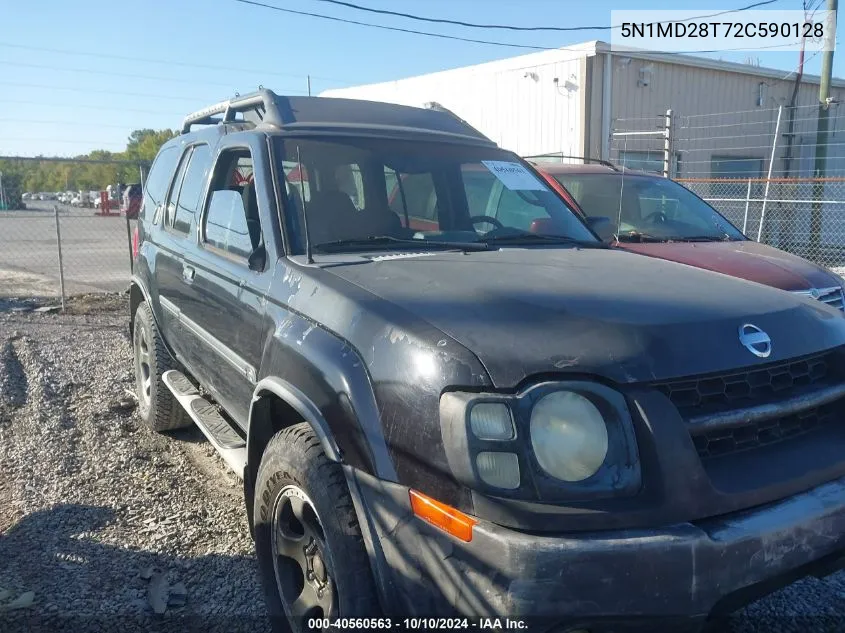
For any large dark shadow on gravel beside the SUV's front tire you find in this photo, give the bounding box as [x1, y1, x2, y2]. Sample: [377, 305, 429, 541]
[0, 504, 269, 633]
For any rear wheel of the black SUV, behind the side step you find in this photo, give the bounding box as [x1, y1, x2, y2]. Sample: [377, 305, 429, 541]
[132, 301, 193, 432]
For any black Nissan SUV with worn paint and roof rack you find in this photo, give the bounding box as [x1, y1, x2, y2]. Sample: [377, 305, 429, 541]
[131, 90, 845, 630]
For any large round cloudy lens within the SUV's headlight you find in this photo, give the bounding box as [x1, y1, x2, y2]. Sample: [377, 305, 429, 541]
[531, 391, 608, 481]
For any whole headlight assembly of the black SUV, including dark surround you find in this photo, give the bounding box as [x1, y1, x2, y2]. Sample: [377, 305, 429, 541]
[440, 380, 642, 504]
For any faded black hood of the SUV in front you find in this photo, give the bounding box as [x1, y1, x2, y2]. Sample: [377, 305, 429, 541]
[325, 248, 845, 388]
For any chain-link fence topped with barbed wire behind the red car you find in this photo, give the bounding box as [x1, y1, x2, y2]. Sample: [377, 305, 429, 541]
[610, 104, 845, 273]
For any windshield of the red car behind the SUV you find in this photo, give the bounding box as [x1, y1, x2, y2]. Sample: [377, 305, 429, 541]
[554, 173, 744, 242]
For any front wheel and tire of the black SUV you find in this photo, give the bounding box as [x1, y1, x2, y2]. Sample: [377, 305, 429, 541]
[254, 423, 380, 633]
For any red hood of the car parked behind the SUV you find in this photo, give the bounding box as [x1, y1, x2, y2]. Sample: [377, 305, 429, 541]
[618, 240, 841, 291]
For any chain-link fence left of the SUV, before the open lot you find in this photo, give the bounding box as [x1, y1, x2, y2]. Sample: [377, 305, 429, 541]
[0, 161, 145, 303]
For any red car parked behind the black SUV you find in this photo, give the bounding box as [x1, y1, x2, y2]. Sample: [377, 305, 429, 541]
[532, 162, 845, 310]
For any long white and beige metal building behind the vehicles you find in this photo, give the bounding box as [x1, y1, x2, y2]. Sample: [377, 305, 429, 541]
[322, 41, 845, 178]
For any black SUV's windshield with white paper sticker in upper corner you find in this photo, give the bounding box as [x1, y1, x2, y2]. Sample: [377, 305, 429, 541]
[276, 138, 597, 253]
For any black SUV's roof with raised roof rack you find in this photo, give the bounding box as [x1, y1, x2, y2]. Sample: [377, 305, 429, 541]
[182, 89, 495, 146]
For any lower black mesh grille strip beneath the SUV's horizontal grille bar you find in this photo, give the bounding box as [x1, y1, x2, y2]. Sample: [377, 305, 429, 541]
[692, 402, 842, 459]
